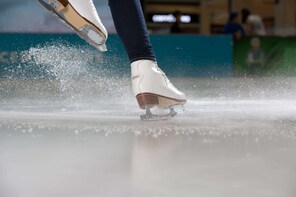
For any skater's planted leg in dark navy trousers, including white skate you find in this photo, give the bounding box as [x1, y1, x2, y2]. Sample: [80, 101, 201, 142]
[109, 0, 186, 119]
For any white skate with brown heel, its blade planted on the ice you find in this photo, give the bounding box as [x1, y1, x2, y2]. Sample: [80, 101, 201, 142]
[131, 60, 186, 120]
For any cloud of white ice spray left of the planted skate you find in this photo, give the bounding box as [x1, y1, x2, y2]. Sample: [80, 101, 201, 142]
[0, 42, 132, 109]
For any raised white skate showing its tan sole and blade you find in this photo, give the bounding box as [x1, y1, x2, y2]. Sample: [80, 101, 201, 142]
[38, 0, 108, 51]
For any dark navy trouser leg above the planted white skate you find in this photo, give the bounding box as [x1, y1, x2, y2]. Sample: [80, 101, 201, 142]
[109, 0, 155, 62]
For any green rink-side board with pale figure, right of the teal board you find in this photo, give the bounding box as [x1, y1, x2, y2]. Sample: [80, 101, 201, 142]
[233, 37, 296, 77]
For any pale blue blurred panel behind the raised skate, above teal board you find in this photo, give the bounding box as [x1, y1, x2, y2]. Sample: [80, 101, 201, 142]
[0, 0, 114, 33]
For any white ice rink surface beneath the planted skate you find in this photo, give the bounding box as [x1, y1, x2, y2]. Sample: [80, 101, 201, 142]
[0, 53, 296, 197]
